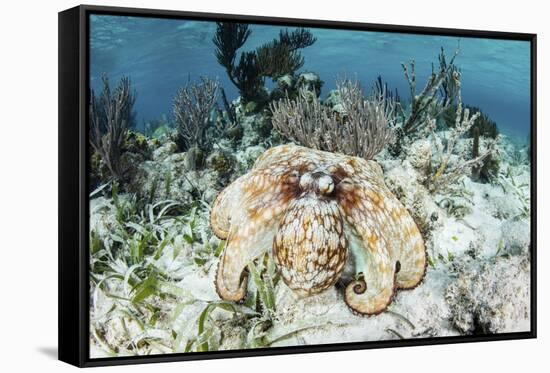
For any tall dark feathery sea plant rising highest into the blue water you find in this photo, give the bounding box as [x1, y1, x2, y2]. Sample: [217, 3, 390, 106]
[213, 22, 316, 103]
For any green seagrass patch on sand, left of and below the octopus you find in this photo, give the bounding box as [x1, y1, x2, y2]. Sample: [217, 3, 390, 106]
[89, 183, 344, 356]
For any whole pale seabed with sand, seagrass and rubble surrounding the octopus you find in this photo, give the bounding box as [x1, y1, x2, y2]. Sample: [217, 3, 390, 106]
[90, 104, 531, 357]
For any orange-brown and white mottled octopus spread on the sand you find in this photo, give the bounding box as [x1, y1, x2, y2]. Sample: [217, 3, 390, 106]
[210, 145, 427, 315]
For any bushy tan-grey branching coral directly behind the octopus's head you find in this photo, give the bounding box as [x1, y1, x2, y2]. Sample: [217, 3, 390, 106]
[270, 79, 395, 159]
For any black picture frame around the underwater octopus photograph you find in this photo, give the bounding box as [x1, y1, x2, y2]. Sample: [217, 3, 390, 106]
[58, 5, 537, 367]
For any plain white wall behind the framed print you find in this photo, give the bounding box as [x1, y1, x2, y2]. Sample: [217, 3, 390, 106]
[0, 0, 550, 373]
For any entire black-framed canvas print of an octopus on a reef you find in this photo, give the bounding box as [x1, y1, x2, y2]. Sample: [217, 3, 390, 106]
[59, 6, 536, 366]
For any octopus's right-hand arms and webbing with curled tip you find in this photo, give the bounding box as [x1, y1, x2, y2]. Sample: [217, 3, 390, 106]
[339, 159, 426, 314]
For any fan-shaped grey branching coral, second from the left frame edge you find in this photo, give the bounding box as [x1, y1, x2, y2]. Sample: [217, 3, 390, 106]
[174, 77, 218, 168]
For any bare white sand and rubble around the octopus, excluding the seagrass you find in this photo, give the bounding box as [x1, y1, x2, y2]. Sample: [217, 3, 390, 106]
[90, 117, 531, 357]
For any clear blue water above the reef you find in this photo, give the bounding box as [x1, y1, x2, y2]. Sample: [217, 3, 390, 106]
[90, 15, 530, 138]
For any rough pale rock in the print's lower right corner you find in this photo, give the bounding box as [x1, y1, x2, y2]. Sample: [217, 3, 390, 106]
[445, 256, 530, 334]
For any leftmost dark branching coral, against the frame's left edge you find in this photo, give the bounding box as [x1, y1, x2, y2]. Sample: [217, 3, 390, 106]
[90, 76, 136, 180]
